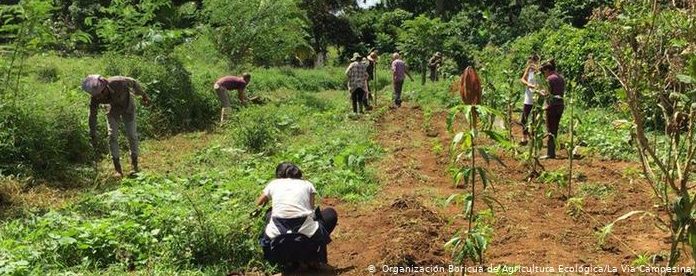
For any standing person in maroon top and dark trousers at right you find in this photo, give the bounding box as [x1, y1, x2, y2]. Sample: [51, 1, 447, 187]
[540, 59, 566, 159]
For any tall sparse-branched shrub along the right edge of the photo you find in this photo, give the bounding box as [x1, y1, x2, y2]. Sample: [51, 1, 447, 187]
[601, 1, 696, 266]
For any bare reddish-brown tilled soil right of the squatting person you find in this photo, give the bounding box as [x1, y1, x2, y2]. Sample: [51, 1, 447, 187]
[323, 102, 676, 275]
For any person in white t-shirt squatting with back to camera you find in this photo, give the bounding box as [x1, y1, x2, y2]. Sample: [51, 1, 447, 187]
[256, 162, 338, 271]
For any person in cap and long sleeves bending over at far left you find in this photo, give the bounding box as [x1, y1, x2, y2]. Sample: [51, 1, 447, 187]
[82, 75, 150, 178]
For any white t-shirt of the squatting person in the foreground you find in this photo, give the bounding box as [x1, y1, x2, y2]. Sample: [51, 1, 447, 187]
[263, 178, 319, 239]
